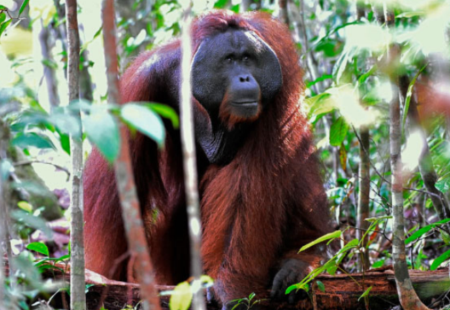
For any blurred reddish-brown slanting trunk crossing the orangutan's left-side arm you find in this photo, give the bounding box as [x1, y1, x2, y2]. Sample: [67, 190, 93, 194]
[102, 0, 160, 310]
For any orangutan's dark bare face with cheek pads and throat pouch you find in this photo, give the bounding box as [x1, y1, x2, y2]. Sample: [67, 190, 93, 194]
[191, 29, 282, 164]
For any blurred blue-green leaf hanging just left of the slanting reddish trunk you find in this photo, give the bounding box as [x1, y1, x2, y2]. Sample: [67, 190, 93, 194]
[83, 110, 120, 163]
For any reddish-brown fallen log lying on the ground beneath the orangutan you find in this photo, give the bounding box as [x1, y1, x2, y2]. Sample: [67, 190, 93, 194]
[3, 264, 450, 310]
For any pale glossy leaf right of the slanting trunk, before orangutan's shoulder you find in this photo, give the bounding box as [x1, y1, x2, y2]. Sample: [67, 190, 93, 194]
[120, 103, 165, 146]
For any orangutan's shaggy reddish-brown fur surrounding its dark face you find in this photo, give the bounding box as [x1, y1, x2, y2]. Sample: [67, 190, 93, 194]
[84, 12, 328, 301]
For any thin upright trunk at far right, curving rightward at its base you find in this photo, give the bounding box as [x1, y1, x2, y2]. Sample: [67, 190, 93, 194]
[384, 4, 428, 309]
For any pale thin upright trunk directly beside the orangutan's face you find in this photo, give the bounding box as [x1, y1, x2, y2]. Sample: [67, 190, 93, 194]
[180, 3, 205, 310]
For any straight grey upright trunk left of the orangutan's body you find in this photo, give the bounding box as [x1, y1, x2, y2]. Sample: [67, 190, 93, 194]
[66, 0, 86, 310]
